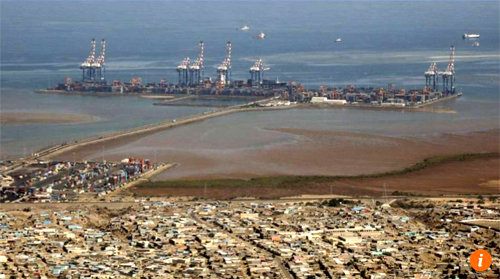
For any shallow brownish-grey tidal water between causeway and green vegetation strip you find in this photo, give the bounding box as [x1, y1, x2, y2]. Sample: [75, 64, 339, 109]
[51, 109, 499, 180]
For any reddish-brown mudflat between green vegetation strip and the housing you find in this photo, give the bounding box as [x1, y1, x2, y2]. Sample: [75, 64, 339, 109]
[131, 156, 500, 201]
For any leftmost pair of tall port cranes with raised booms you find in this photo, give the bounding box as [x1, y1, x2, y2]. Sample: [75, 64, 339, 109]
[80, 39, 106, 83]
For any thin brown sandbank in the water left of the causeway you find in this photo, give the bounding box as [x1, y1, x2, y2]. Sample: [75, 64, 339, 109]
[0, 112, 99, 125]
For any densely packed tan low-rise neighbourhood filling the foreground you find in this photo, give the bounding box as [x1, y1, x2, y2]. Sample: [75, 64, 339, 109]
[0, 199, 500, 278]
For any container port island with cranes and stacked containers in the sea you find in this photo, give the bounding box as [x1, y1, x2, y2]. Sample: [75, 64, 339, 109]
[37, 39, 462, 109]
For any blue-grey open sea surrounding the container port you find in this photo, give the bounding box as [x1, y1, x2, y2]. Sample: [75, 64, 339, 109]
[0, 1, 500, 159]
